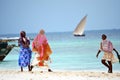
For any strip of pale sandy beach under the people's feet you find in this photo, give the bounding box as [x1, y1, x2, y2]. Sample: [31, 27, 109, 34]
[0, 70, 120, 80]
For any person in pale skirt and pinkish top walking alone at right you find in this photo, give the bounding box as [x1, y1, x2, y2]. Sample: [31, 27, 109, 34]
[96, 34, 120, 73]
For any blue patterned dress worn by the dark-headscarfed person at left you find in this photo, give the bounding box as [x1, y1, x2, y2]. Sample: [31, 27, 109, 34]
[18, 39, 32, 67]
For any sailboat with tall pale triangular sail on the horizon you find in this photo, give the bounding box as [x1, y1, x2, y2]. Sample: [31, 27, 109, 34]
[73, 15, 87, 36]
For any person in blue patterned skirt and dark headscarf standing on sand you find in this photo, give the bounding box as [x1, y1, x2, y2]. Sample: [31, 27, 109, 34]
[18, 31, 32, 72]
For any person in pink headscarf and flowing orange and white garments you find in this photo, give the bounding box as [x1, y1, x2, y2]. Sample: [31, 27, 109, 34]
[31, 29, 52, 72]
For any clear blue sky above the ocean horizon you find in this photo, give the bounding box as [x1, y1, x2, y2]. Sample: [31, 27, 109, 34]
[0, 0, 120, 34]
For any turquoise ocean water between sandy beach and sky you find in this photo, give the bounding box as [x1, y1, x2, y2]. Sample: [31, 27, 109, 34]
[0, 29, 120, 71]
